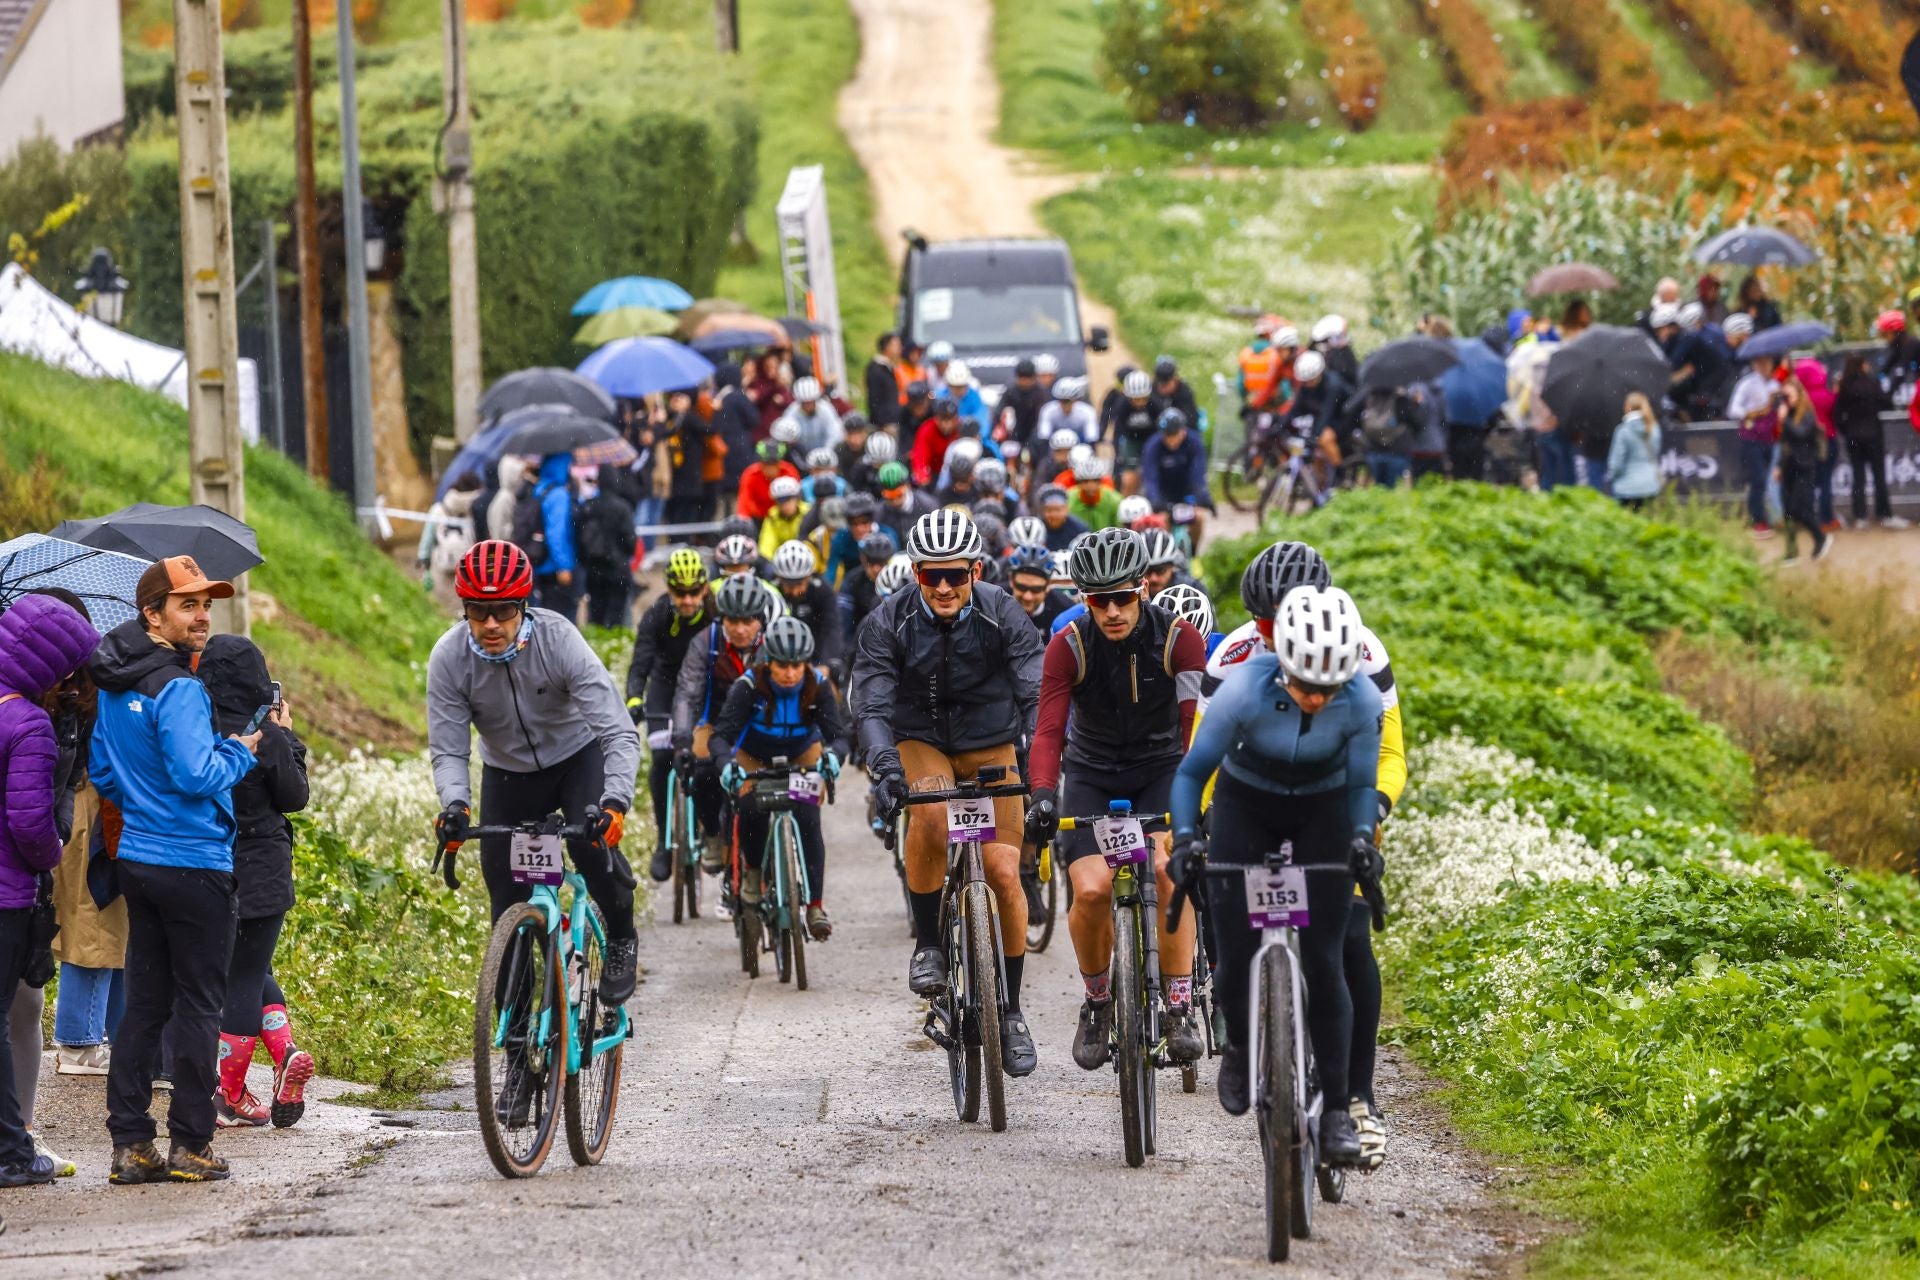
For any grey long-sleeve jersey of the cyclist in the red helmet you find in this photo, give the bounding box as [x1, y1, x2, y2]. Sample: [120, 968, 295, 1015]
[426, 608, 639, 806]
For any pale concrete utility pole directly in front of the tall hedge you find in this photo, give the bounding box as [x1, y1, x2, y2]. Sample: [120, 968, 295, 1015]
[434, 0, 480, 443]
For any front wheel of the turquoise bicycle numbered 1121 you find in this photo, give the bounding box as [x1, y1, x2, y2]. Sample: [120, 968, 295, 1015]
[474, 902, 568, 1178]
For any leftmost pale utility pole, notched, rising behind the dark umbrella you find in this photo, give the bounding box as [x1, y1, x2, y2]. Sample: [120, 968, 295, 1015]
[173, 0, 250, 635]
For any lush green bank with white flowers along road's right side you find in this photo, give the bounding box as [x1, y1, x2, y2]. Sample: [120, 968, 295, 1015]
[1208, 486, 1920, 1278]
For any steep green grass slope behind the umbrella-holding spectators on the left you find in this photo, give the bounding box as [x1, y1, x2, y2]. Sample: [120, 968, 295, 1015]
[0, 353, 447, 748]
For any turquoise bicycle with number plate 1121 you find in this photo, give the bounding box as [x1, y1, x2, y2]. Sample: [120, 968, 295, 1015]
[434, 806, 636, 1178]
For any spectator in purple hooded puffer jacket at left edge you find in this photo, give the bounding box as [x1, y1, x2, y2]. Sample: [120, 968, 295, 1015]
[0, 595, 100, 1186]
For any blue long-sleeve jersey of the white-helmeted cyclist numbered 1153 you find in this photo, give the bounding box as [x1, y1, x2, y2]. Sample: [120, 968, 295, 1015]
[1173, 652, 1384, 837]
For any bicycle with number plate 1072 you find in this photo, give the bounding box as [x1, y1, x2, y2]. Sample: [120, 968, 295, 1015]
[906, 764, 1027, 1134]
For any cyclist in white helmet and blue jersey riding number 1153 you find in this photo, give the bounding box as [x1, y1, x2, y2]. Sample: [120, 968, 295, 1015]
[1171, 587, 1382, 1165]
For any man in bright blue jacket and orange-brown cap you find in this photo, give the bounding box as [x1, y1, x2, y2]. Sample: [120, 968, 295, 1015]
[88, 557, 259, 1186]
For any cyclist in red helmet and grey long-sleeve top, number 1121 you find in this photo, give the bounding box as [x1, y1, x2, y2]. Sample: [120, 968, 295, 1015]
[426, 539, 639, 1004]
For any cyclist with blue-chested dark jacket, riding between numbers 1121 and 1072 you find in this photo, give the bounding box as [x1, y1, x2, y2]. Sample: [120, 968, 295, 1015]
[707, 618, 847, 942]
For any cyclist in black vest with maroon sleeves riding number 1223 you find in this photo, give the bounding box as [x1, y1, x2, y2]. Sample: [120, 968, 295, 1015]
[1027, 530, 1206, 1071]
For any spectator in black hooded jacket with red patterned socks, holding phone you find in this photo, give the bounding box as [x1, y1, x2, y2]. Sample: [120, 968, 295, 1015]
[200, 635, 313, 1128]
